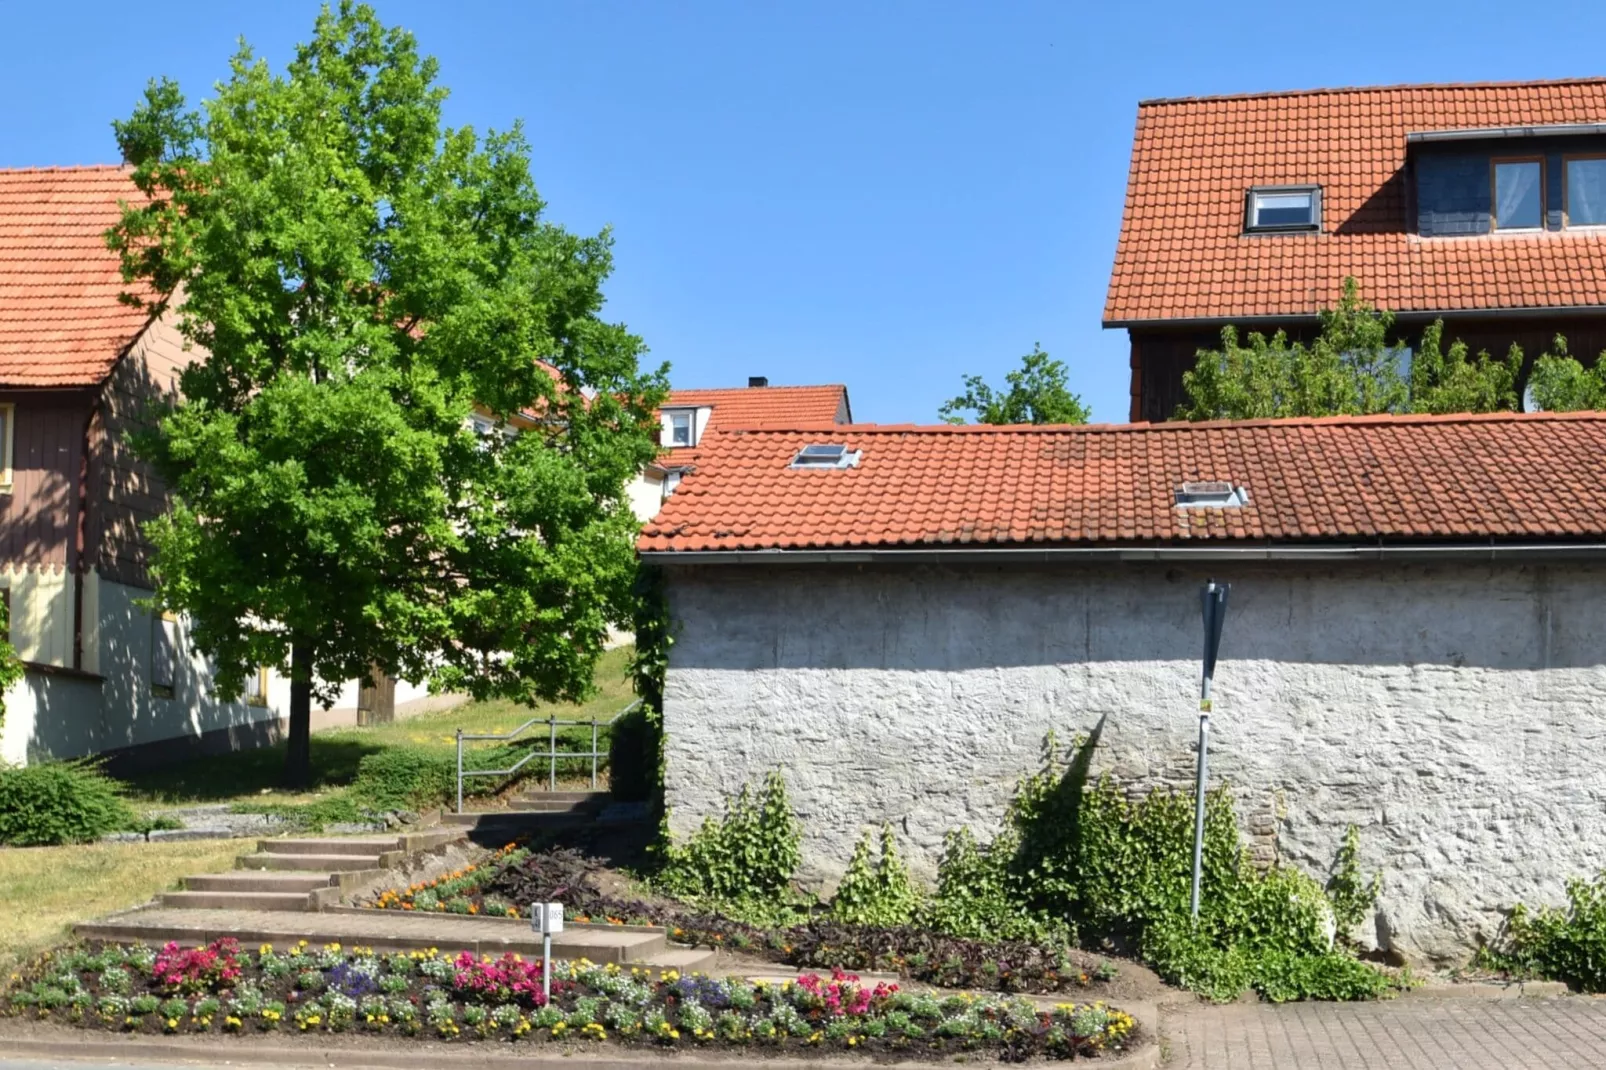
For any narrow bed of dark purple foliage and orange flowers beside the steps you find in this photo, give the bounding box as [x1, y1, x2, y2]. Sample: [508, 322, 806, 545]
[362, 845, 1115, 994]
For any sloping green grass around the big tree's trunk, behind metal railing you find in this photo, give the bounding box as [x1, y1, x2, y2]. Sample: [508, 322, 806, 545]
[125, 646, 636, 807]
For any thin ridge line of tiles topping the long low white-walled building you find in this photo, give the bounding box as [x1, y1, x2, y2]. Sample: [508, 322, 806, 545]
[722, 410, 1606, 435]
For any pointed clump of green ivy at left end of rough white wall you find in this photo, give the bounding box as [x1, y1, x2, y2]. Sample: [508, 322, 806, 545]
[660, 771, 803, 903]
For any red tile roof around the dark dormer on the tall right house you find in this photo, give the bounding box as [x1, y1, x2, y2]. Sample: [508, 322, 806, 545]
[1105, 79, 1606, 326]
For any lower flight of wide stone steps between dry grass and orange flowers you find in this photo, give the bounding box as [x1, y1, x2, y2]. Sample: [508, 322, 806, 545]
[161, 827, 464, 911]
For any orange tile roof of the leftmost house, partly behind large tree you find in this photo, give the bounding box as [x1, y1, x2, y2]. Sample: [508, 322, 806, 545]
[0, 167, 149, 387]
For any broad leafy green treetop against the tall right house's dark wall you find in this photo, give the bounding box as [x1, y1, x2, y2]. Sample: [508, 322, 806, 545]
[1177, 278, 1522, 419]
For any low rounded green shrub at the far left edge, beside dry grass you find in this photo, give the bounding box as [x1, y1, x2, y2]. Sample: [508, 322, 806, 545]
[0, 762, 135, 847]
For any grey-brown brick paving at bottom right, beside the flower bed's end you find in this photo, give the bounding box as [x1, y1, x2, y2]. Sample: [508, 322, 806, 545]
[1160, 996, 1606, 1070]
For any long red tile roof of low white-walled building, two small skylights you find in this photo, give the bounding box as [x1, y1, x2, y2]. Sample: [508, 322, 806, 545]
[638, 413, 1606, 551]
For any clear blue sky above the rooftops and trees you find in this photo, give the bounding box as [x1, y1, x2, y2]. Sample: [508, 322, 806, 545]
[0, 0, 1606, 423]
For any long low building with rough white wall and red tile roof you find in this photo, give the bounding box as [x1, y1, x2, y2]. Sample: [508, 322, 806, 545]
[639, 413, 1606, 962]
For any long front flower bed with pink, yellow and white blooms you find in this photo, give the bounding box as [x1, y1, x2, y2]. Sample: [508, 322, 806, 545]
[10, 940, 1135, 1060]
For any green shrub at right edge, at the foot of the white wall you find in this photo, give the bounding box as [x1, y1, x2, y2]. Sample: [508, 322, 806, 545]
[1479, 872, 1606, 993]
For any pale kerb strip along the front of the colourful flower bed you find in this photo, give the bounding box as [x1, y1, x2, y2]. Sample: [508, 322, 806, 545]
[0, 1027, 1160, 1070]
